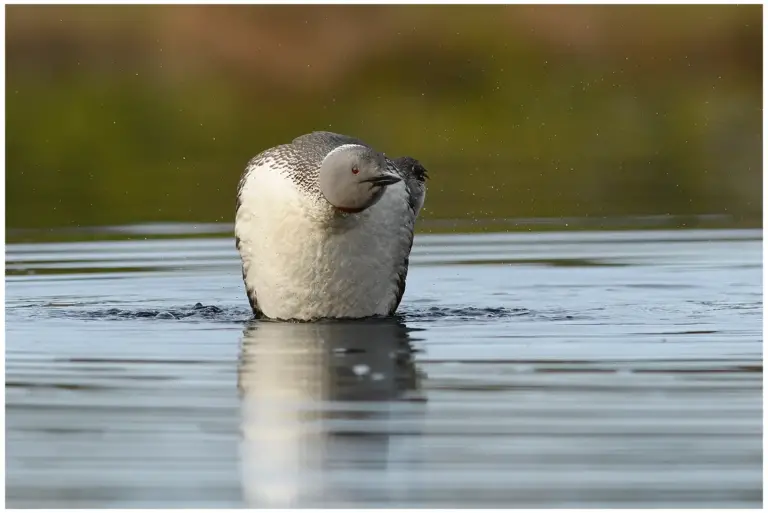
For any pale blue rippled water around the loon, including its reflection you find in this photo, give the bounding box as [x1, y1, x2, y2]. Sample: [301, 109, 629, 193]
[6, 229, 763, 508]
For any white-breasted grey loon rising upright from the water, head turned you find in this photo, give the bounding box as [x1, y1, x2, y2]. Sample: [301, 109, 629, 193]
[235, 131, 428, 321]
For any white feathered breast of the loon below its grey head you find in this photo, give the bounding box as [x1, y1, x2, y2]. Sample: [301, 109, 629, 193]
[235, 161, 413, 320]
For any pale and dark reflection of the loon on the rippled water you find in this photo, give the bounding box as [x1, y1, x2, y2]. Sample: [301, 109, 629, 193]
[238, 319, 423, 507]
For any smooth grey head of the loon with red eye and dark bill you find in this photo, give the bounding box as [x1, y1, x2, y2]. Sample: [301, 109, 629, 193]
[318, 144, 403, 213]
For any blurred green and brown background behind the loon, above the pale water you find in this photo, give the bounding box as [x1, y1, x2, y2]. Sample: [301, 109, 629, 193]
[6, 5, 762, 236]
